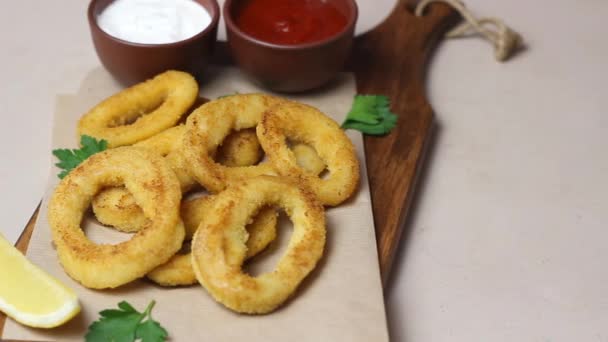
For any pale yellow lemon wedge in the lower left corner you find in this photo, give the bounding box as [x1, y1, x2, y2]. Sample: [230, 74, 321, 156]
[0, 234, 80, 328]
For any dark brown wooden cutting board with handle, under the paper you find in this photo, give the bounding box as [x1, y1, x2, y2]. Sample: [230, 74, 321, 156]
[0, 0, 459, 336]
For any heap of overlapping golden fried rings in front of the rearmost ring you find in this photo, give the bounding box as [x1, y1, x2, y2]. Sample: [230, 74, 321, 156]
[49, 73, 359, 313]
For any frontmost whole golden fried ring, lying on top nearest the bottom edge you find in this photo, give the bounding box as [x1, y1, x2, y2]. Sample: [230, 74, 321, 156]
[192, 176, 326, 314]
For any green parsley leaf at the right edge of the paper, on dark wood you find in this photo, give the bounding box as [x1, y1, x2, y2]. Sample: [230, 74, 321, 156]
[342, 95, 397, 135]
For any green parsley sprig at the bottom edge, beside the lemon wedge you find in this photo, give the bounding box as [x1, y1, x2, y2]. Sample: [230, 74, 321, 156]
[85, 301, 169, 342]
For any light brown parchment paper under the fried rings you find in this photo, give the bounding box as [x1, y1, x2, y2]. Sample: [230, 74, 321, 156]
[3, 68, 388, 341]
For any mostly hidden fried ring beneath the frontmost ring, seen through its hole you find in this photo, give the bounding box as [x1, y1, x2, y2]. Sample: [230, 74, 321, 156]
[147, 196, 277, 286]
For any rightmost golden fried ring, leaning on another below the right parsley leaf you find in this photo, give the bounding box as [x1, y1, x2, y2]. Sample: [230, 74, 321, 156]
[257, 101, 359, 206]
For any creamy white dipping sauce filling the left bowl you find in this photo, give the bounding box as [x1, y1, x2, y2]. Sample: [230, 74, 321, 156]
[97, 0, 211, 44]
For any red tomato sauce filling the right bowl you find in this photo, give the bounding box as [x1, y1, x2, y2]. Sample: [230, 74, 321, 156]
[235, 0, 347, 45]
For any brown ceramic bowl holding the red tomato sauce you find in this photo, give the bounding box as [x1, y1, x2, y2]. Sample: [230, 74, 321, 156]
[222, 0, 358, 92]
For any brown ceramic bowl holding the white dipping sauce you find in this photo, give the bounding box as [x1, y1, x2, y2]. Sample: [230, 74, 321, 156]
[88, 0, 220, 85]
